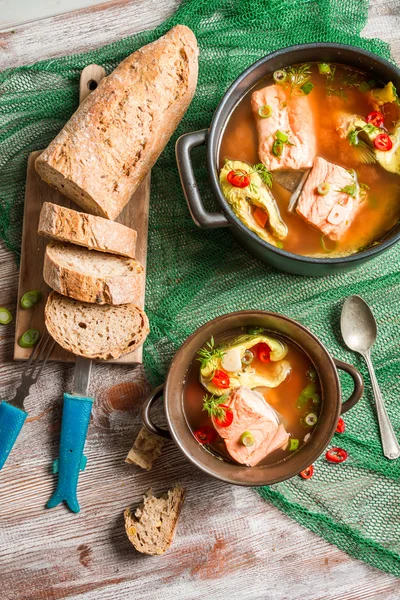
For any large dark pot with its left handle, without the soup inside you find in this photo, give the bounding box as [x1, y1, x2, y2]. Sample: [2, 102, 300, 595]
[176, 44, 400, 275]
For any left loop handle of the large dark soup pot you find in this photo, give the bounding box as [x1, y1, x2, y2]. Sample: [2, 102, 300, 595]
[175, 129, 230, 229]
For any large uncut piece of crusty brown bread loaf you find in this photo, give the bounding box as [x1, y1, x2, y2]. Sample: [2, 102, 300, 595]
[36, 25, 198, 219]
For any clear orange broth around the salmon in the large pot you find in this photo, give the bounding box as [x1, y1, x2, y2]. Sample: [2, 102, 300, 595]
[219, 64, 400, 258]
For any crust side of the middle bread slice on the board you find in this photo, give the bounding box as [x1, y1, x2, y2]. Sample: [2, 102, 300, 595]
[43, 242, 145, 306]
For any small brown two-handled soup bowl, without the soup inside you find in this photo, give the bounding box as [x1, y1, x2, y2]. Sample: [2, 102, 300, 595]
[142, 311, 364, 486]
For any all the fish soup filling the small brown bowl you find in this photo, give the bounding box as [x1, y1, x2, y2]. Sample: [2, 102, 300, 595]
[184, 327, 321, 467]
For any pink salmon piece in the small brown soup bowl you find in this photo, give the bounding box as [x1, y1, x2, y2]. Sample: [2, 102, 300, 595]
[213, 387, 289, 467]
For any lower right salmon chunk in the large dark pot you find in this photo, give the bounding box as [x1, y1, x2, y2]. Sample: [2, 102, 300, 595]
[296, 157, 361, 240]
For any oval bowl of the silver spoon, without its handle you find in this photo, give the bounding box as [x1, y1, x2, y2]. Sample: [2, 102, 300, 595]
[340, 296, 377, 354]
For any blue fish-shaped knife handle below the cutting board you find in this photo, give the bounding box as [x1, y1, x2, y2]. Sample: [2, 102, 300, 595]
[46, 394, 93, 513]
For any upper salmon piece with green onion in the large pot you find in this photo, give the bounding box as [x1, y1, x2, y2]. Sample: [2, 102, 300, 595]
[251, 85, 317, 171]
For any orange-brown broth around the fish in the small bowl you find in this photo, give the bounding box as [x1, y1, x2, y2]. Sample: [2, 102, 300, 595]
[183, 328, 321, 466]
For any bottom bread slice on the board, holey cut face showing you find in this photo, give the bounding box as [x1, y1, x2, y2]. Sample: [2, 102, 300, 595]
[44, 292, 149, 360]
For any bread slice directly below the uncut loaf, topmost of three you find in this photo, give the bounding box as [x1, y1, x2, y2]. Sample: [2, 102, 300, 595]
[38, 202, 137, 258]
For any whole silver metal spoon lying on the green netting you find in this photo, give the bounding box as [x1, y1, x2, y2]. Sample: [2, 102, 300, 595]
[340, 296, 400, 460]
